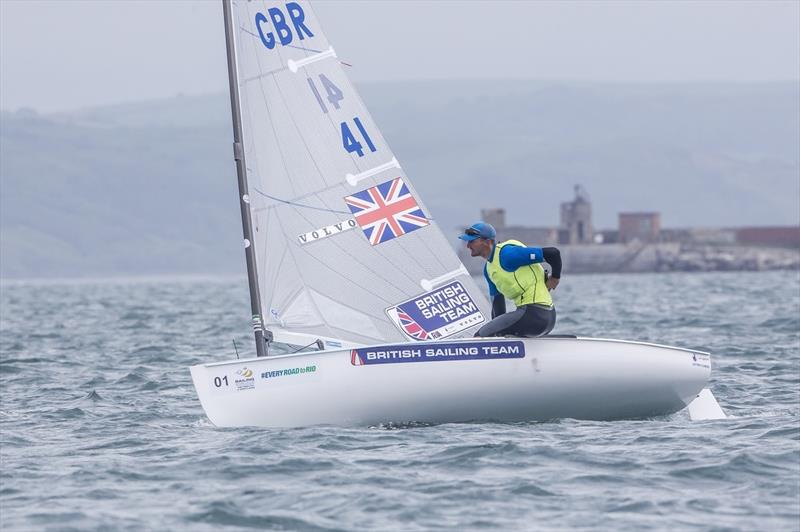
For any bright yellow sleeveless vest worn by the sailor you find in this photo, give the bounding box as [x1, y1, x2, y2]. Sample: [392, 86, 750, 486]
[486, 240, 553, 307]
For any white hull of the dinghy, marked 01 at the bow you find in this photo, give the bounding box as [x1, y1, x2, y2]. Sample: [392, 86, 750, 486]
[191, 337, 711, 427]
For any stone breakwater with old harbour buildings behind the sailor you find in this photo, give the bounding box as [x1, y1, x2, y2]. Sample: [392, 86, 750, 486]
[457, 185, 800, 275]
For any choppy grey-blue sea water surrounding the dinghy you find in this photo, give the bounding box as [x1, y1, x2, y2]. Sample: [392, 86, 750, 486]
[0, 271, 800, 531]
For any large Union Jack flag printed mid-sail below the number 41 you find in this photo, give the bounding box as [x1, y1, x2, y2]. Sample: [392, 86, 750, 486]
[344, 177, 430, 246]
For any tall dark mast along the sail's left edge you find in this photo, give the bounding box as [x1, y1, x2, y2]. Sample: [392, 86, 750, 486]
[222, 0, 272, 357]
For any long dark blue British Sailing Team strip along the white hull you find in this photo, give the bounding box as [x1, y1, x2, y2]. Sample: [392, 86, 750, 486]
[350, 341, 525, 366]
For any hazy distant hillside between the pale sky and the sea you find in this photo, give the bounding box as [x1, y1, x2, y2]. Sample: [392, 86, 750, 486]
[0, 81, 800, 277]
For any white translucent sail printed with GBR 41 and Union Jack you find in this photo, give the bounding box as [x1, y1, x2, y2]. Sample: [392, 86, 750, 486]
[228, 0, 488, 344]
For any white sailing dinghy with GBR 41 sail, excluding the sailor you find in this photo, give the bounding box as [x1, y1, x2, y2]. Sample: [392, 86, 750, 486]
[191, 0, 724, 427]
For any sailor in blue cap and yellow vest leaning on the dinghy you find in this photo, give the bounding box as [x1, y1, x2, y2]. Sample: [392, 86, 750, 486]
[458, 222, 561, 336]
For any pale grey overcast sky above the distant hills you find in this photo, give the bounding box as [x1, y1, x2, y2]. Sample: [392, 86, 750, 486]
[0, 0, 800, 112]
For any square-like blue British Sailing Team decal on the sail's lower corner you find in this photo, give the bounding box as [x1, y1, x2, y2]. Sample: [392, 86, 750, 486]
[386, 281, 486, 342]
